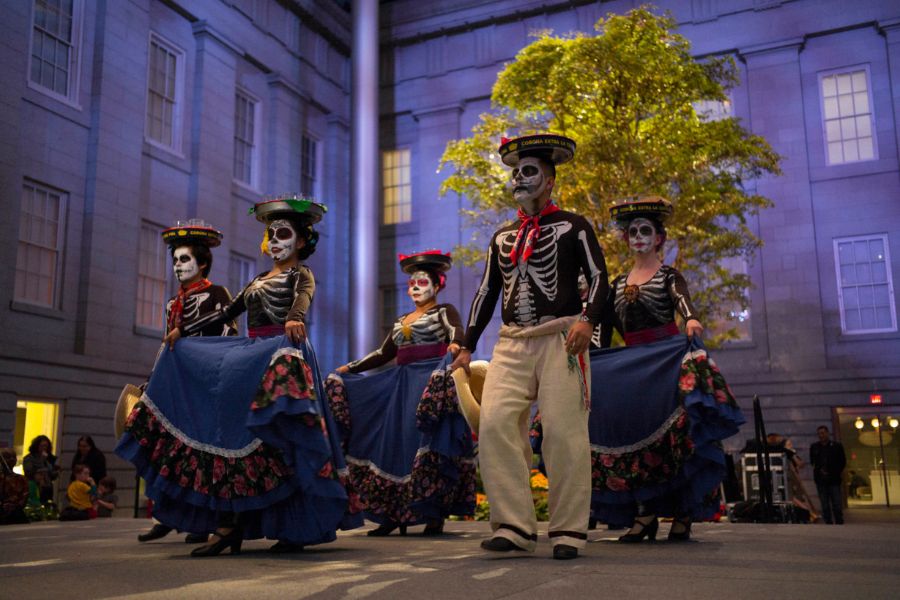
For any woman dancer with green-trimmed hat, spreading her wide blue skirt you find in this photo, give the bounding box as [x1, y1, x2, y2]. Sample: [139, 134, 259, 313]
[116, 196, 362, 556]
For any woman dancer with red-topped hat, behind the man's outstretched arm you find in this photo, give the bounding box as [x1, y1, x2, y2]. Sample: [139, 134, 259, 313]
[327, 250, 475, 536]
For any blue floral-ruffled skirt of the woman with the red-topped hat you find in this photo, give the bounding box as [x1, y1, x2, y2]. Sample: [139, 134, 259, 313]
[326, 355, 475, 525]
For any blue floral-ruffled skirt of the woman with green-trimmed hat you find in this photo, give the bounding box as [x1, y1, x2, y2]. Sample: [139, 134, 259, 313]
[115, 335, 362, 545]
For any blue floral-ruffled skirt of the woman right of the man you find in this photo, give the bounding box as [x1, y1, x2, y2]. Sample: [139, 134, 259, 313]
[533, 335, 745, 526]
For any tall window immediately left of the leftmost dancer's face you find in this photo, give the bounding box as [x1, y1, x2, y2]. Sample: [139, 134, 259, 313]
[135, 223, 169, 330]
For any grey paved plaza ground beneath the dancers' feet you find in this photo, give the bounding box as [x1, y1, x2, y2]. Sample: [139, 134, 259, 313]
[0, 509, 900, 600]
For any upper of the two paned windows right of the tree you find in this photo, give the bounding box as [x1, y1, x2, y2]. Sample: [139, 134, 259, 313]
[819, 69, 877, 165]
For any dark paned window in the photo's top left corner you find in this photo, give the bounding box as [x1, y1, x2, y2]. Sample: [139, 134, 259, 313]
[29, 0, 81, 101]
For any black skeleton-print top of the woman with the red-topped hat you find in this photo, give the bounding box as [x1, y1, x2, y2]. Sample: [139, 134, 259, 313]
[347, 304, 463, 373]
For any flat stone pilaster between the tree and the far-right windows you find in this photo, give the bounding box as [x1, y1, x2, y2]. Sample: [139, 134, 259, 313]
[741, 40, 826, 372]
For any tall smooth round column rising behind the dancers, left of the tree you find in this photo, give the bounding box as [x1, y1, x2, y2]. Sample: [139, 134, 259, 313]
[350, 0, 380, 357]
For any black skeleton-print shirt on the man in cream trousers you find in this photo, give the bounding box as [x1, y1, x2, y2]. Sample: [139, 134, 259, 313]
[464, 210, 609, 352]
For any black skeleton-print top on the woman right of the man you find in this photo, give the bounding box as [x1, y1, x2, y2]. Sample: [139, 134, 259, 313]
[601, 265, 697, 347]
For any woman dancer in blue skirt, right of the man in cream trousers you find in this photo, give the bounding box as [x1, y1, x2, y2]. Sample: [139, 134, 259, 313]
[589, 197, 744, 542]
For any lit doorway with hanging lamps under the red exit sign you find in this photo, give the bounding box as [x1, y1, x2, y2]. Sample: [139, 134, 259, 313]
[835, 405, 900, 508]
